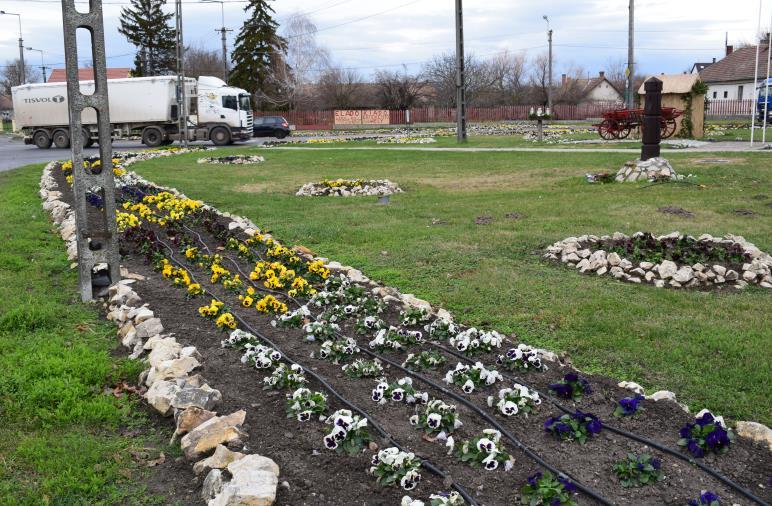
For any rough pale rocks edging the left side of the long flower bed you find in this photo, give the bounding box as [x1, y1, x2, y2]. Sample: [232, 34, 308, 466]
[40, 162, 280, 506]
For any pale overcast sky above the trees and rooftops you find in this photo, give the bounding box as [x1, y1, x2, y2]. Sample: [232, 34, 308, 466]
[0, 0, 772, 81]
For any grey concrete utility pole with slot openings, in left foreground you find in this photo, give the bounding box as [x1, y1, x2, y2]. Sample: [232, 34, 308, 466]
[62, 0, 121, 302]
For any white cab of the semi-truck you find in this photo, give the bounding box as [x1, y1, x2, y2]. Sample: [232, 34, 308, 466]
[196, 76, 254, 146]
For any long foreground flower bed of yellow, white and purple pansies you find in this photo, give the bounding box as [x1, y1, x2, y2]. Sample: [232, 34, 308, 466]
[41, 156, 772, 506]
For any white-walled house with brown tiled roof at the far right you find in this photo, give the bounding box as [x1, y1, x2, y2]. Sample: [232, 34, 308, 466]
[700, 42, 770, 100]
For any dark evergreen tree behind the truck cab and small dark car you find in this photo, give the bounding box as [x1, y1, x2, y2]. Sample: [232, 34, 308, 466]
[231, 0, 287, 102]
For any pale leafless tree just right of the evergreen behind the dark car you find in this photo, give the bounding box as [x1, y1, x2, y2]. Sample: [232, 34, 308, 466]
[275, 13, 330, 108]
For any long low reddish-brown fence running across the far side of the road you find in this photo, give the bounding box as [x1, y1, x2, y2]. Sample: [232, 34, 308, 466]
[256, 100, 754, 130]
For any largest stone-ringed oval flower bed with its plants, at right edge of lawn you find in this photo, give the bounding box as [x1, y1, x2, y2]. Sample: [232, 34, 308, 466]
[544, 232, 772, 288]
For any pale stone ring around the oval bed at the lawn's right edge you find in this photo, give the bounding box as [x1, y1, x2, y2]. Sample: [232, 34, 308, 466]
[544, 232, 772, 289]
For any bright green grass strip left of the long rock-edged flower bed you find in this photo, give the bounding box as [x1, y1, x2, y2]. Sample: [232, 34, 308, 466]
[0, 166, 168, 505]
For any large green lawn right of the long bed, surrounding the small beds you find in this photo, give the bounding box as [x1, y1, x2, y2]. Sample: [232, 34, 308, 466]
[135, 148, 772, 424]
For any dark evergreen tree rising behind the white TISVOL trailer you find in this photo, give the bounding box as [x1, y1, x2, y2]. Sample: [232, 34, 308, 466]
[118, 0, 177, 77]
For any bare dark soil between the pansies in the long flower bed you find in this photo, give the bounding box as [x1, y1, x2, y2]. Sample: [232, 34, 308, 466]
[51, 164, 772, 505]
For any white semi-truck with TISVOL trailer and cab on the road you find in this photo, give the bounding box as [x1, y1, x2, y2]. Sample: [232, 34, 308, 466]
[11, 76, 253, 149]
